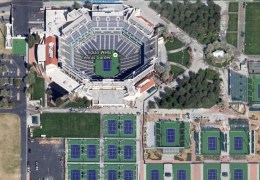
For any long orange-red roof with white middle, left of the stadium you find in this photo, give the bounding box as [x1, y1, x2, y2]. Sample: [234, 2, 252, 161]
[45, 36, 58, 66]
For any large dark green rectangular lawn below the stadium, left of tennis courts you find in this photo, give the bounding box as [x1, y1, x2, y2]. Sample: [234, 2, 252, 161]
[33, 113, 100, 138]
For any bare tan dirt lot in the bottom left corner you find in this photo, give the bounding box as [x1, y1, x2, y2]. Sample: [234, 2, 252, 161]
[0, 114, 21, 180]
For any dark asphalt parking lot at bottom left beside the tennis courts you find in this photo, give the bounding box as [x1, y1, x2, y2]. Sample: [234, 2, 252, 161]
[27, 138, 65, 180]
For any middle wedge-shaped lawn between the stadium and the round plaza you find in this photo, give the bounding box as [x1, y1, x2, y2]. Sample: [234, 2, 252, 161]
[168, 49, 190, 67]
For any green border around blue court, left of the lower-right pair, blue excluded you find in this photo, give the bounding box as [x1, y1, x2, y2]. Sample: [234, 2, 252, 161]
[201, 131, 221, 155]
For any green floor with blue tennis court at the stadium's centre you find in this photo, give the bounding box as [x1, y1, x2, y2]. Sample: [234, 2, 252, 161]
[94, 51, 120, 78]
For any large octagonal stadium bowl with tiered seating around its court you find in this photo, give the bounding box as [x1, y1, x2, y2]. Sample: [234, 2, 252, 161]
[59, 1, 157, 81]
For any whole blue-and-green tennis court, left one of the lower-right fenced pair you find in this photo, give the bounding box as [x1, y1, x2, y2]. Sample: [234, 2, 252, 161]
[201, 130, 221, 155]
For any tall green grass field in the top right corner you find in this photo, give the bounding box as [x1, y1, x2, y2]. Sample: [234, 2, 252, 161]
[244, 2, 260, 55]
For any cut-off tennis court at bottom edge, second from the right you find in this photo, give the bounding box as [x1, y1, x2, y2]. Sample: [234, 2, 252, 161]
[203, 163, 221, 180]
